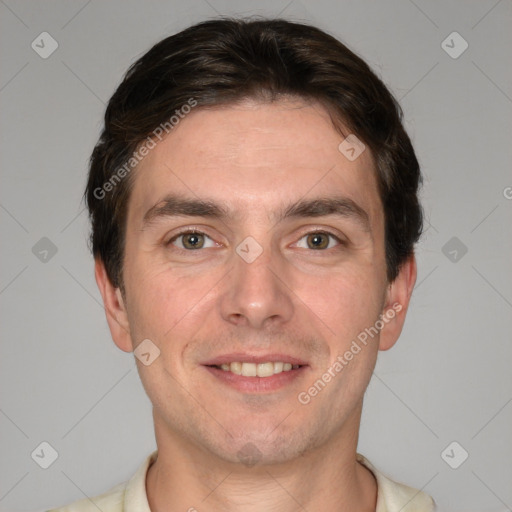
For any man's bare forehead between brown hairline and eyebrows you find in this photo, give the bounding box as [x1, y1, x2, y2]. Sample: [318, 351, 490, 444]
[129, 100, 382, 227]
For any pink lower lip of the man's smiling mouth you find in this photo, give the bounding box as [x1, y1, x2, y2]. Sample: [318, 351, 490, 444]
[205, 366, 308, 393]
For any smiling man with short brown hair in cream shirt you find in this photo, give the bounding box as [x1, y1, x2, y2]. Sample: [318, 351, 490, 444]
[50, 19, 434, 512]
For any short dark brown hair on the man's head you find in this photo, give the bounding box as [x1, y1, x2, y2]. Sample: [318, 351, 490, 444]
[85, 18, 422, 291]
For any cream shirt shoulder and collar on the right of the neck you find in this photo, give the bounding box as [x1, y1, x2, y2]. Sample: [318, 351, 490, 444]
[357, 453, 436, 512]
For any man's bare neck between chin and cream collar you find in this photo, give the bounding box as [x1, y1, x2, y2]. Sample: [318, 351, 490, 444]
[146, 404, 377, 512]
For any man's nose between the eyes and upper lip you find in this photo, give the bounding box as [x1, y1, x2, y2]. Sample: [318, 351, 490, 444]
[220, 242, 294, 329]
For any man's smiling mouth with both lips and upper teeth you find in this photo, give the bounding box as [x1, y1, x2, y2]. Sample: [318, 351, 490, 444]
[203, 354, 309, 393]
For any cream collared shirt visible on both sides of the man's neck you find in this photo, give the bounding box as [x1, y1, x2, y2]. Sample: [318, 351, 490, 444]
[48, 450, 435, 512]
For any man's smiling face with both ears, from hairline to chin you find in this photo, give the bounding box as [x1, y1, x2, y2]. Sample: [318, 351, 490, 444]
[97, 100, 415, 463]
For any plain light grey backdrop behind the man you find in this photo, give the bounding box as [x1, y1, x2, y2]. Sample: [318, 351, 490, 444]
[0, 0, 512, 511]
